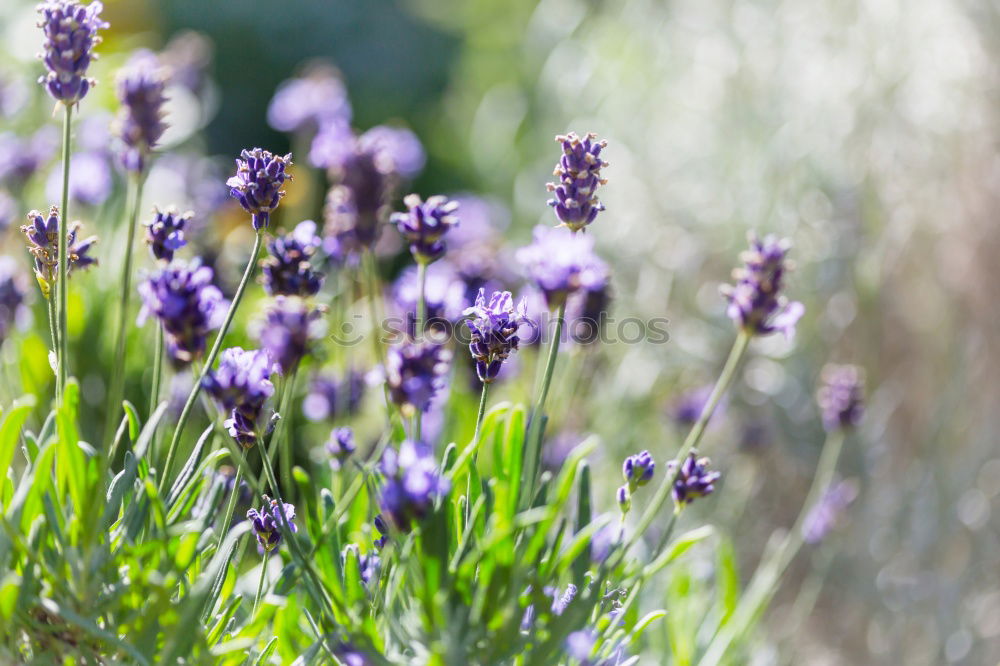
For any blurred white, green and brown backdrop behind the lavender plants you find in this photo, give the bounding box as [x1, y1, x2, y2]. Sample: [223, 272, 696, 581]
[0, 0, 1000, 664]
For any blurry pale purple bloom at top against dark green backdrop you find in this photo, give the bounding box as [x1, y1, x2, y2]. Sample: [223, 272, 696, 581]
[267, 64, 351, 134]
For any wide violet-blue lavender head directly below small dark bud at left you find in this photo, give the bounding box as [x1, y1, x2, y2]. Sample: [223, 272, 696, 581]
[138, 261, 226, 365]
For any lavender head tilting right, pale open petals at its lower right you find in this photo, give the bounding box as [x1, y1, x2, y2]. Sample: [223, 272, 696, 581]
[722, 234, 805, 339]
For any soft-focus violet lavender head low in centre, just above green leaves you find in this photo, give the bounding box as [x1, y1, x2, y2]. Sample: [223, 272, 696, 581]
[379, 440, 450, 532]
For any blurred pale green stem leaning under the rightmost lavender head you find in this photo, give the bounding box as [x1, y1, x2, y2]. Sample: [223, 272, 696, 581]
[699, 430, 844, 666]
